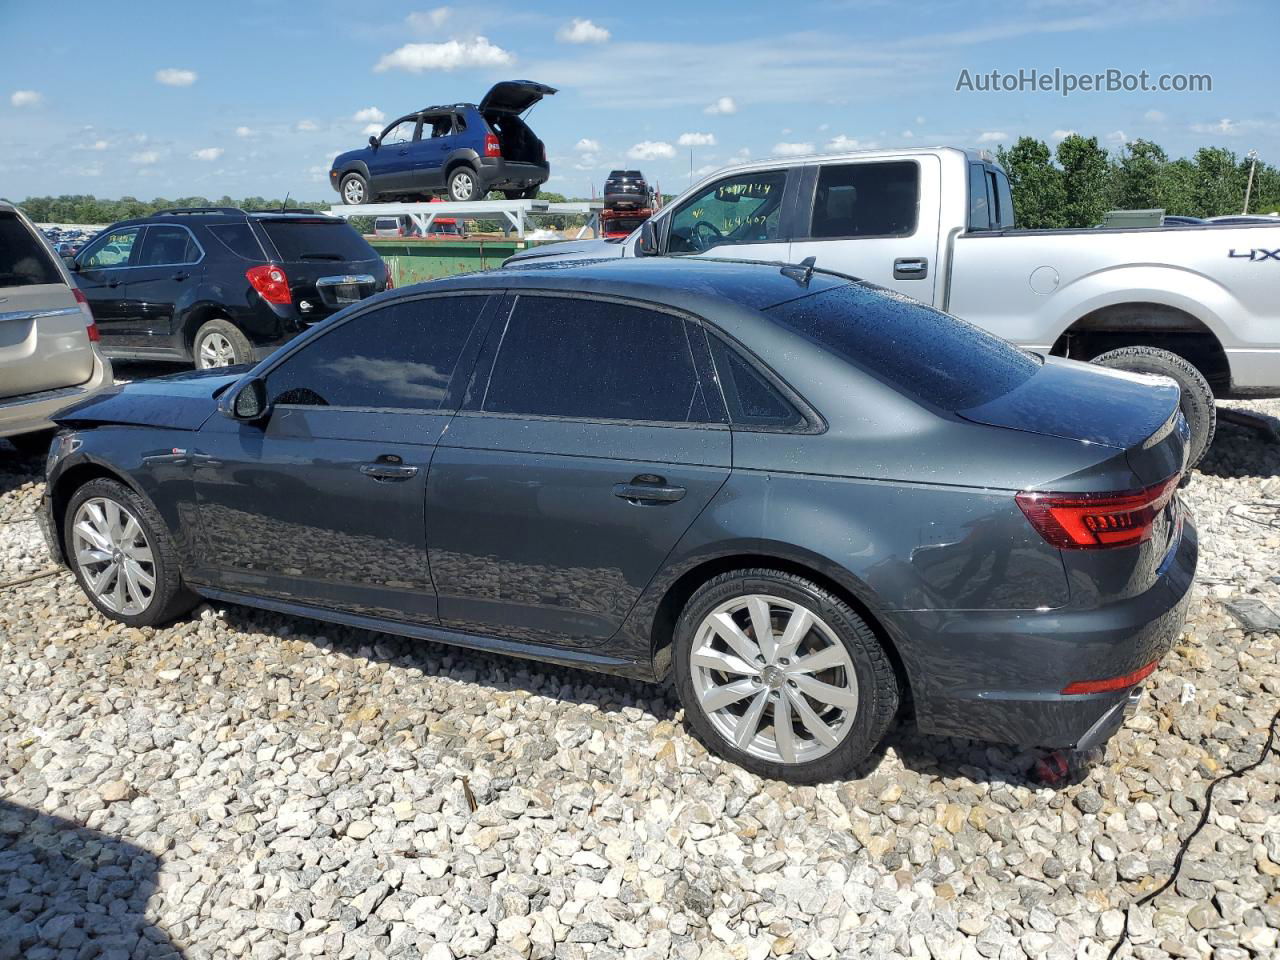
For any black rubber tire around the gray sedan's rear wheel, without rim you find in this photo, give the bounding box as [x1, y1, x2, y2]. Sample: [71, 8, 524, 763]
[672, 570, 901, 783]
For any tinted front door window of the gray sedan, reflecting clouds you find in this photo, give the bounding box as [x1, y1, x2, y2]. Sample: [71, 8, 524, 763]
[266, 296, 488, 410]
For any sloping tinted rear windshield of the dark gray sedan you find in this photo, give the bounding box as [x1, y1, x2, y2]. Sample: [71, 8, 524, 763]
[768, 284, 1041, 412]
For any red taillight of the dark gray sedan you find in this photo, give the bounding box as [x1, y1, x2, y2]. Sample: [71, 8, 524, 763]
[1016, 476, 1179, 550]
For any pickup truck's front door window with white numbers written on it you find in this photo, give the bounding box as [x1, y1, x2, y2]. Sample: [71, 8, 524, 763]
[667, 170, 787, 253]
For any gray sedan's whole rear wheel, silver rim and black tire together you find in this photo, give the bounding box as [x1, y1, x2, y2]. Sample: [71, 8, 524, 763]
[672, 570, 900, 783]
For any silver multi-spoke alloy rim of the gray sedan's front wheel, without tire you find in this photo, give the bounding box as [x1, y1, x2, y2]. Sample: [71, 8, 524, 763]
[72, 497, 156, 616]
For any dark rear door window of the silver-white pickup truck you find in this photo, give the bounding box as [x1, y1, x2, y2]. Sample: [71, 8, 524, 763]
[809, 160, 920, 239]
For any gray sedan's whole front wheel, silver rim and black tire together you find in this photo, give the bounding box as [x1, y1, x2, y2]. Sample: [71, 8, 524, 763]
[63, 479, 197, 627]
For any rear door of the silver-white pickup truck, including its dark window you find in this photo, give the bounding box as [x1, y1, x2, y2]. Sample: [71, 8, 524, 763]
[791, 156, 941, 303]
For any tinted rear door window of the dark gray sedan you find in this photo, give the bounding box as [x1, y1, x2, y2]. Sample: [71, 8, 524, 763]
[481, 297, 710, 424]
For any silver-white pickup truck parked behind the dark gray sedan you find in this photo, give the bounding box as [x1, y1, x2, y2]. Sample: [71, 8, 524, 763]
[508, 147, 1280, 461]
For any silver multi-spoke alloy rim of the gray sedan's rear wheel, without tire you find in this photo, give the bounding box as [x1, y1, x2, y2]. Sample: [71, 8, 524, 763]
[689, 594, 858, 763]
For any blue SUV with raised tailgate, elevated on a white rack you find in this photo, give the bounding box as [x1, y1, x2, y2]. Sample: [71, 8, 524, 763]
[329, 81, 556, 204]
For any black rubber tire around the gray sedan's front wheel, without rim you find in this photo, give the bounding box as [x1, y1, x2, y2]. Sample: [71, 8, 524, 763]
[63, 477, 200, 627]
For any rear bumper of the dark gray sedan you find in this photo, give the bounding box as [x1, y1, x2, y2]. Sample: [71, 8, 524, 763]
[895, 516, 1198, 749]
